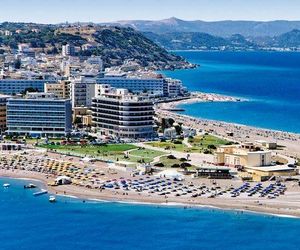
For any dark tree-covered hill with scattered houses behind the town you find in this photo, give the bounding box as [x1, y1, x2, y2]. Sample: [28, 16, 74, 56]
[0, 23, 191, 69]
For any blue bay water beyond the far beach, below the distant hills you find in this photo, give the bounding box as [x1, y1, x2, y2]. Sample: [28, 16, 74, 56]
[163, 51, 300, 133]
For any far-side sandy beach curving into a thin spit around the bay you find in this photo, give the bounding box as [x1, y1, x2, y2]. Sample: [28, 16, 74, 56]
[155, 93, 300, 157]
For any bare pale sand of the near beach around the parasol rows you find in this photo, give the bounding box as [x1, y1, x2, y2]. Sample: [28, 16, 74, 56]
[0, 147, 300, 217]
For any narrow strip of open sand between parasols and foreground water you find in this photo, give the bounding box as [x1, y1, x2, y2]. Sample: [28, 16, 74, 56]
[0, 170, 300, 219]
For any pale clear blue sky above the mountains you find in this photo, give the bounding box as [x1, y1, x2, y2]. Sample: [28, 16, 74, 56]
[0, 0, 300, 23]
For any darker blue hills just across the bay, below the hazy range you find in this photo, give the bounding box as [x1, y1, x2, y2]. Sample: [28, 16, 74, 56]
[144, 30, 300, 50]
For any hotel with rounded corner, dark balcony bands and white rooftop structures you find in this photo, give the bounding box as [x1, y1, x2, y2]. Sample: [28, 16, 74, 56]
[92, 85, 154, 139]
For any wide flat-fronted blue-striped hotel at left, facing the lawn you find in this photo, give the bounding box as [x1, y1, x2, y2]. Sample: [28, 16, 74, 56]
[7, 93, 72, 137]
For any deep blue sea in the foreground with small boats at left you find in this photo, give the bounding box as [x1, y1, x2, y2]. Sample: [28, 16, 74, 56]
[0, 178, 300, 250]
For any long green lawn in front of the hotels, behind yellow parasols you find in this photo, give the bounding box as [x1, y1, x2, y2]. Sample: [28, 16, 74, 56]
[40, 144, 163, 163]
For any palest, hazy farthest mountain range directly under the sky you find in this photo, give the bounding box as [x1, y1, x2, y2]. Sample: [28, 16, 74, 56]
[106, 17, 300, 37]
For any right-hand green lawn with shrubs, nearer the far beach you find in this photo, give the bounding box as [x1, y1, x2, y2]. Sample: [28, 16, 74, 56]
[147, 135, 228, 153]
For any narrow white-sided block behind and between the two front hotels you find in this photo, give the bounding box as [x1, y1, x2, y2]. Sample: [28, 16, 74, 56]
[70, 76, 96, 108]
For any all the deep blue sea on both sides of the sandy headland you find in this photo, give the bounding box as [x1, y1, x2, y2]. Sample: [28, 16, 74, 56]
[0, 52, 300, 250]
